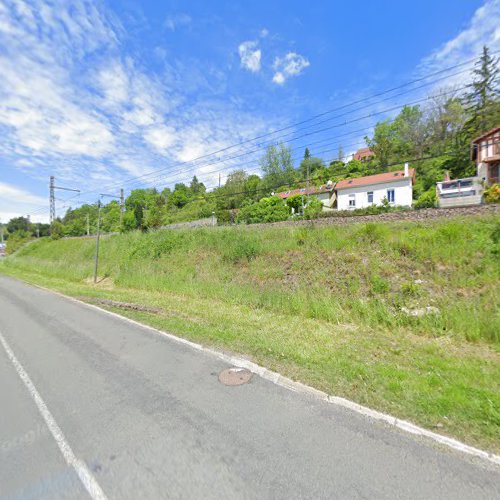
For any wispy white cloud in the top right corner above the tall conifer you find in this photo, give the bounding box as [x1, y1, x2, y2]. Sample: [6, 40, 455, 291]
[419, 0, 500, 85]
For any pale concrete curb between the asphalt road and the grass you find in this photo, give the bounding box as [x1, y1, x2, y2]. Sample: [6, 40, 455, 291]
[24, 282, 500, 465]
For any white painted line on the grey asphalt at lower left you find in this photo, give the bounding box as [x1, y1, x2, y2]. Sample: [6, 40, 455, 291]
[0, 332, 106, 500]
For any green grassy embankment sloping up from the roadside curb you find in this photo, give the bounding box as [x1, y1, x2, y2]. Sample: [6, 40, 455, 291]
[0, 217, 500, 452]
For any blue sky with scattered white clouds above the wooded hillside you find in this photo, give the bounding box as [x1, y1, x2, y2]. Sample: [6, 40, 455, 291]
[0, 0, 500, 221]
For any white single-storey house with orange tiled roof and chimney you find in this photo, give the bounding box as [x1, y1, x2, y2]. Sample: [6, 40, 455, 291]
[335, 163, 415, 210]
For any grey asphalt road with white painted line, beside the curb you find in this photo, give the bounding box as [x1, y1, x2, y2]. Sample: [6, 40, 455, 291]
[0, 277, 500, 500]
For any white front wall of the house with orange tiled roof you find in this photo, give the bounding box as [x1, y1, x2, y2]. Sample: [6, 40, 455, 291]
[337, 178, 413, 210]
